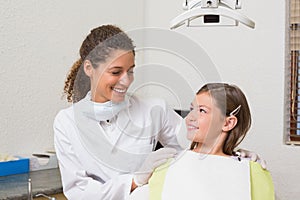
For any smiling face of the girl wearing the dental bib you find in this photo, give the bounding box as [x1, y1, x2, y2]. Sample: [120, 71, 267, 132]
[186, 92, 225, 146]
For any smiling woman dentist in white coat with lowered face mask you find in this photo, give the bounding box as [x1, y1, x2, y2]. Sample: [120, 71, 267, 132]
[53, 25, 262, 200]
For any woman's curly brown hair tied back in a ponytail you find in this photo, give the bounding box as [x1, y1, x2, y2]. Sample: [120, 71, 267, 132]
[64, 25, 134, 103]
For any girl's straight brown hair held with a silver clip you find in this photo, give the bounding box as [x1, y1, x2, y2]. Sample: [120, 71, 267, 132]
[191, 83, 251, 155]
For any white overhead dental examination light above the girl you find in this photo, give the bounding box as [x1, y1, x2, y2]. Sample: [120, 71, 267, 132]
[170, 0, 255, 29]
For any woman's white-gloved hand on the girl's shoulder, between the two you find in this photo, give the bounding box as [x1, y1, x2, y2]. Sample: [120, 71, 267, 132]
[133, 147, 176, 186]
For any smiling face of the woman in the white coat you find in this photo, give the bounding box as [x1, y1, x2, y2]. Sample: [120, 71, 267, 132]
[86, 50, 135, 103]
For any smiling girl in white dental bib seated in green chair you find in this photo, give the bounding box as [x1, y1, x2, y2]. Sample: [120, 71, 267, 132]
[132, 83, 275, 200]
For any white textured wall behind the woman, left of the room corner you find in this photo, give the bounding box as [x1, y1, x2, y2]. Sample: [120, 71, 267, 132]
[0, 0, 144, 155]
